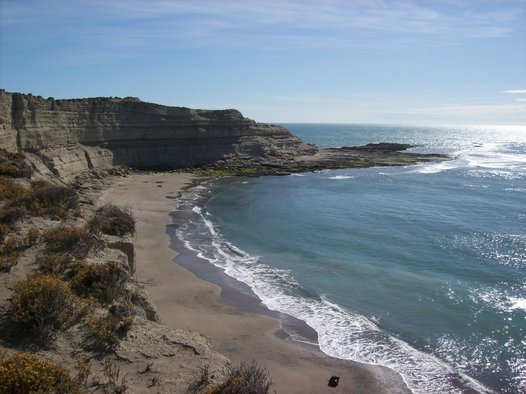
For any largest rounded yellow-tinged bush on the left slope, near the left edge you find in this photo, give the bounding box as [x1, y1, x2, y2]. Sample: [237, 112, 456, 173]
[7, 275, 84, 344]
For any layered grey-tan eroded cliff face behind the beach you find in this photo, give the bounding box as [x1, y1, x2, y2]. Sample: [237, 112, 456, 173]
[0, 91, 317, 181]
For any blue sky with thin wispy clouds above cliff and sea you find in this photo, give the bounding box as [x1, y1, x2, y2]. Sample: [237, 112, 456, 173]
[0, 0, 526, 125]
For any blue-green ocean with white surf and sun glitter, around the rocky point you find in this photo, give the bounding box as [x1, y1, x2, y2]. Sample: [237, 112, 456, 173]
[174, 124, 526, 393]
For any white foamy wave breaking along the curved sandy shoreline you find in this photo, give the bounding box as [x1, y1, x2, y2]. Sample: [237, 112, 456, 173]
[172, 190, 488, 393]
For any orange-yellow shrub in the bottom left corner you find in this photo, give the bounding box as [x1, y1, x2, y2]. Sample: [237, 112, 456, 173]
[0, 353, 81, 394]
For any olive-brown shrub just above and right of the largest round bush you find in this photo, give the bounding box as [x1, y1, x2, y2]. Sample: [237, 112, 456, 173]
[71, 261, 129, 304]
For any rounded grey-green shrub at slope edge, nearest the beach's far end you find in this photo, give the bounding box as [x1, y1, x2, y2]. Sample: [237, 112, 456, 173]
[90, 204, 135, 236]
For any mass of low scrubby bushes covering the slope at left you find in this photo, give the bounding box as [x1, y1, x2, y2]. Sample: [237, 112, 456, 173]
[0, 149, 153, 393]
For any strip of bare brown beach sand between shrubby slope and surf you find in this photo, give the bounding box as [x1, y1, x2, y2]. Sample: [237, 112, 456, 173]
[100, 173, 410, 394]
